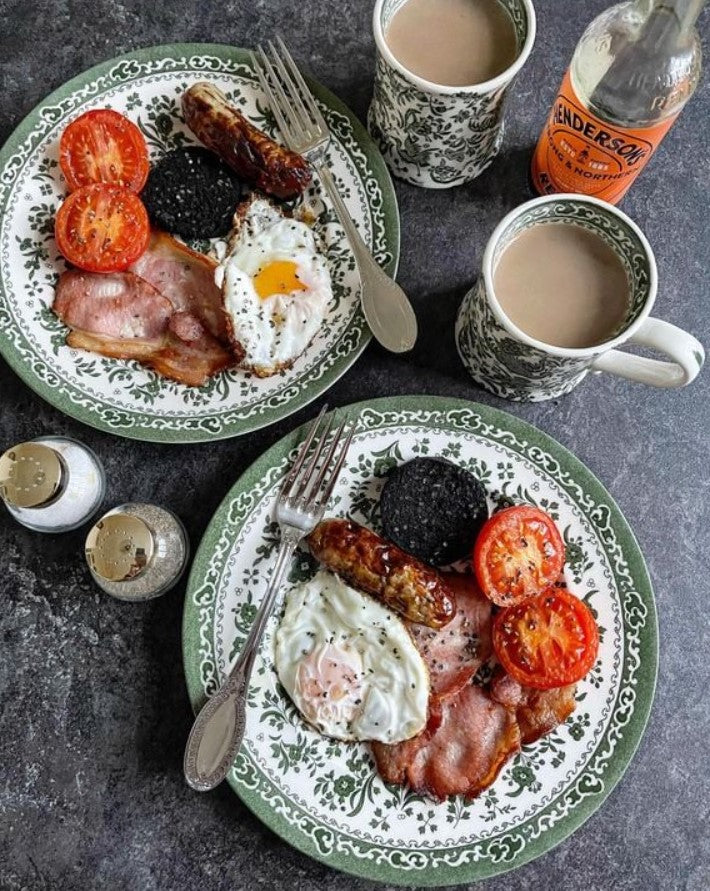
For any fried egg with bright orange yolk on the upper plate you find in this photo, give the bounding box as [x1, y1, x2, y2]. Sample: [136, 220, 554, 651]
[215, 198, 333, 377]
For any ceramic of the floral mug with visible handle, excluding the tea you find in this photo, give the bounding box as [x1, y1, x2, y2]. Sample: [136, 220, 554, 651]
[456, 195, 705, 402]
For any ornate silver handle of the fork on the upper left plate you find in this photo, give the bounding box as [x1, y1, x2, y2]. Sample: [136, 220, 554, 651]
[310, 162, 417, 353]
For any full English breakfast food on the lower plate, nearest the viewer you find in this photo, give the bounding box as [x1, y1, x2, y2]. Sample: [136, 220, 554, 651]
[275, 458, 599, 801]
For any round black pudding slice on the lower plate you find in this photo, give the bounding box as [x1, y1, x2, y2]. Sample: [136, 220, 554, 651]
[380, 458, 488, 566]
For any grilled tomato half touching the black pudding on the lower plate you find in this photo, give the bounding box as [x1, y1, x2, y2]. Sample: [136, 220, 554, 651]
[473, 504, 565, 606]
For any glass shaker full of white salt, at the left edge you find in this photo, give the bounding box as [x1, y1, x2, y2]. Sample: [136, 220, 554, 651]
[0, 436, 106, 532]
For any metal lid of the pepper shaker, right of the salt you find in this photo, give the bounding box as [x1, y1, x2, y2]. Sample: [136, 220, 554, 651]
[85, 513, 155, 582]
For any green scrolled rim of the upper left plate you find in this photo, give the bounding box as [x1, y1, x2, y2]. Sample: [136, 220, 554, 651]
[0, 44, 399, 442]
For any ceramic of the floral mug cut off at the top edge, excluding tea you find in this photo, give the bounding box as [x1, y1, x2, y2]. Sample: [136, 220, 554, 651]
[367, 0, 535, 189]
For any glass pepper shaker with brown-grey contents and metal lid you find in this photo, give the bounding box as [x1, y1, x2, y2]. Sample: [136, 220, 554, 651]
[85, 503, 190, 601]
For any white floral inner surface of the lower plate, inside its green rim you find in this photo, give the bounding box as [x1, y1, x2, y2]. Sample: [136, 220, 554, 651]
[211, 427, 623, 850]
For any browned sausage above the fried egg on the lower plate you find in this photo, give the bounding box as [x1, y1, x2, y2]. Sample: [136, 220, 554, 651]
[307, 520, 456, 628]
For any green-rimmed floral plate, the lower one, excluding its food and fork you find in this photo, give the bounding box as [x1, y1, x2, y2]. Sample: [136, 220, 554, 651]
[183, 396, 658, 885]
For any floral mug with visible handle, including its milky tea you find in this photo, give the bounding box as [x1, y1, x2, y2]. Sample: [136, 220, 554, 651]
[456, 195, 705, 402]
